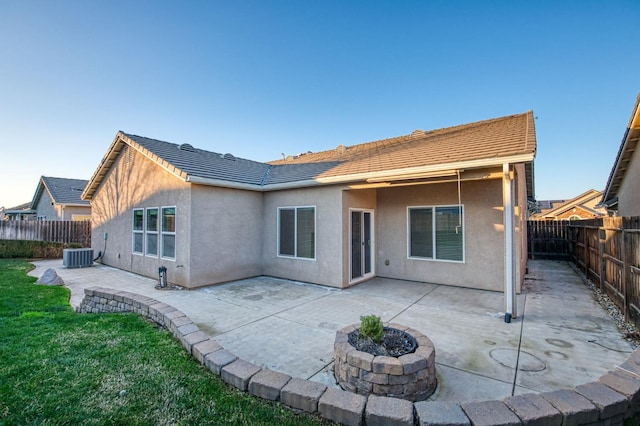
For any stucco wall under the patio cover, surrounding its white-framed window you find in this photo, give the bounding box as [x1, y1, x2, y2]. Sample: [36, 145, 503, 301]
[376, 179, 505, 291]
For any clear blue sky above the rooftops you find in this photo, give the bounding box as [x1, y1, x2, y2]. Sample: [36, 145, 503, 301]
[0, 0, 640, 207]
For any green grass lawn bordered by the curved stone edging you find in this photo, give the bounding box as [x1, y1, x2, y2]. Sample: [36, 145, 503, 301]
[0, 259, 330, 425]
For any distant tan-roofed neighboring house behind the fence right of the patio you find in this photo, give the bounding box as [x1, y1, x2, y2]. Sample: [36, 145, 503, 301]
[531, 189, 607, 220]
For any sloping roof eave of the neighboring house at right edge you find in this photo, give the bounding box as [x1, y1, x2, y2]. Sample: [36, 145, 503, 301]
[602, 94, 640, 208]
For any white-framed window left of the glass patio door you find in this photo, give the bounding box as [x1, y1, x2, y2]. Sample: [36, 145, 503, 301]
[278, 207, 316, 259]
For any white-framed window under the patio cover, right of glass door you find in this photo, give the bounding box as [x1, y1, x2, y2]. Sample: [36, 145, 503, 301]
[408, 206, 464, 262]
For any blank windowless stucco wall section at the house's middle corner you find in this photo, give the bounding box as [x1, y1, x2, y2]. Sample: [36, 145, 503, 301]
[185, 185, 264, 287]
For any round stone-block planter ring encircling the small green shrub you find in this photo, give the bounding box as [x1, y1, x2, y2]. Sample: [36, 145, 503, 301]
[333, 323, 437, 402]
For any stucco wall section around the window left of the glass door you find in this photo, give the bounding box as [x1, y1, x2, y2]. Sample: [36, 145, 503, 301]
[262, 187, 346, 287]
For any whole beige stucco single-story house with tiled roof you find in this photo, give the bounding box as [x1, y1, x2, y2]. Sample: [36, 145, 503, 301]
[82, 111, 536, 316]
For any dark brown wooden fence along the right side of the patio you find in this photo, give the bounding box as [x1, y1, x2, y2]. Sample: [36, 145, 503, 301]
[527, 217, 640, 327]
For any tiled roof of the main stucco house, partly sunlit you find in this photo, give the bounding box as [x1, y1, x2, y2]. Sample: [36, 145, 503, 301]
[83, 111, 536, 199]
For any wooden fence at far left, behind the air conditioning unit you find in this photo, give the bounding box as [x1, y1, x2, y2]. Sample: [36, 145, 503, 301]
[0, 220, 91, 247]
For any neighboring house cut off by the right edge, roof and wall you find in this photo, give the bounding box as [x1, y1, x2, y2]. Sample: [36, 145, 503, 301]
[602, 91, 640, 216]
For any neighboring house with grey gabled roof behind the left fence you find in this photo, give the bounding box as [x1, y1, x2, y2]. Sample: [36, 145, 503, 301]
[31, 176, 91, 220]
